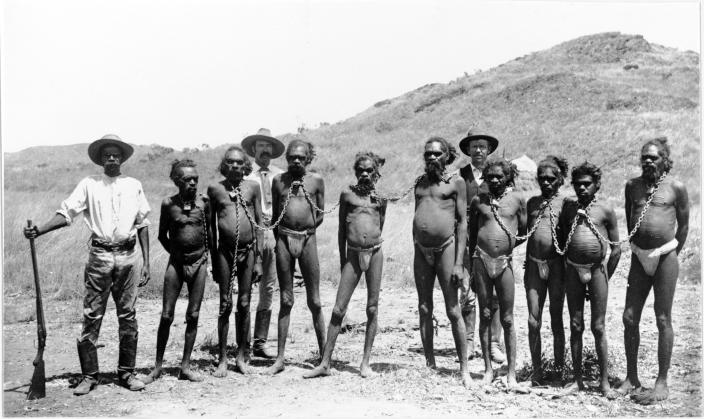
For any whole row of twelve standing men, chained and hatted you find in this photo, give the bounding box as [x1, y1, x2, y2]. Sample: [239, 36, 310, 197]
[24, 129, 688, 403]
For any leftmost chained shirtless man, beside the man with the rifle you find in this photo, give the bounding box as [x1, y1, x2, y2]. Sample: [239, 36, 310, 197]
[144, 160, 210, 384]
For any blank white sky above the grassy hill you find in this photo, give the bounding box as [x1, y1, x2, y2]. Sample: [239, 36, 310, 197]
[0, 0, 701, 151]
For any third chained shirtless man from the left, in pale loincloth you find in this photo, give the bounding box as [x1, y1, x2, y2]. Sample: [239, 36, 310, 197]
[267, 139, 325, 374]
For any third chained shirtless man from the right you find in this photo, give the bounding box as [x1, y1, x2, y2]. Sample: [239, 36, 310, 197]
[523, 156, 567, 385]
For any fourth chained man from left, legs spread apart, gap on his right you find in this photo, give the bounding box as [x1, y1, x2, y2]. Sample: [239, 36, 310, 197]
[303, 152, 387, 378]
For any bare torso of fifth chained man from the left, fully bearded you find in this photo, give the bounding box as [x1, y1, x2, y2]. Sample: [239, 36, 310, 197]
[413, 178, 457, 247]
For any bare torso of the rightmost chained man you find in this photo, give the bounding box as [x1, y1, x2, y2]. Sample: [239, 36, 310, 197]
[627, 177, 677, 249]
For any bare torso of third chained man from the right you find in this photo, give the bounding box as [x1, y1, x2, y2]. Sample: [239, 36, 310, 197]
[527, 194, 564, 259]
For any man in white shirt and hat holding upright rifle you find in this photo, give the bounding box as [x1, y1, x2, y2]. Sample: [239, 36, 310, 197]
[24, 134, 150, 395]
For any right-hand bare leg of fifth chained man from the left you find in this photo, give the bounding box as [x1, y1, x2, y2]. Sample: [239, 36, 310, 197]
[436, 243, 472, 387]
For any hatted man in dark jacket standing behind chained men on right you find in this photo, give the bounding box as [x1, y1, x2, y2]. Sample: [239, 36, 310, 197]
[459, 130, 506, 364]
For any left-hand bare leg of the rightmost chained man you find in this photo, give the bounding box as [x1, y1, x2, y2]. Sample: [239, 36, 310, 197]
[617, 254, 653, 394]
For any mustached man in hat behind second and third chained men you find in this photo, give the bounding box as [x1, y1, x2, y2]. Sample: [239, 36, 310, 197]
[242, 128, 285, 358]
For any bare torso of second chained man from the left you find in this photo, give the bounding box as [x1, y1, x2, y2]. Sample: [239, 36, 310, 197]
[208, 180, 258, 249]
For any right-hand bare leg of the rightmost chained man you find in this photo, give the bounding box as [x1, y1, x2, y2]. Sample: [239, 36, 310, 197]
[634, 252, 679, 404]
